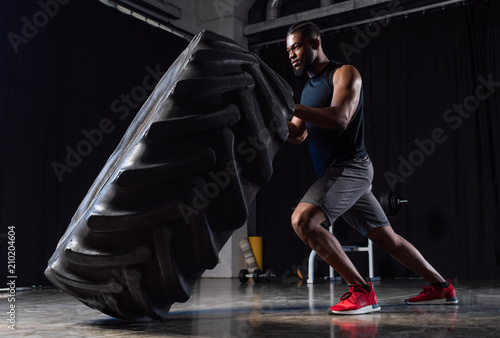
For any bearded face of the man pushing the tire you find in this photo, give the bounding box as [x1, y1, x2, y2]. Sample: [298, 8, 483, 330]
[286, 33, 314, 76]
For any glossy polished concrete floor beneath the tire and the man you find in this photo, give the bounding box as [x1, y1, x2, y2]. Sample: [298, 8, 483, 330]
[0, 279, 500, 338]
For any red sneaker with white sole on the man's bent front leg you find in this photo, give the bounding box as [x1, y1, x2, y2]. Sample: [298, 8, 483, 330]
[329, 282, 380, 315]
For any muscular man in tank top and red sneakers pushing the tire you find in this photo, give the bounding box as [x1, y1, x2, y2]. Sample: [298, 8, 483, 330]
[286, 21, 458, 314]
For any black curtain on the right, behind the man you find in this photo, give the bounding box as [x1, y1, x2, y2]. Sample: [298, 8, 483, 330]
[257, 0, 500, 278]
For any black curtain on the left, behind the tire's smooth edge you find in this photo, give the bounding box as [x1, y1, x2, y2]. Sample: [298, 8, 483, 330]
[0, 0, 188, 286]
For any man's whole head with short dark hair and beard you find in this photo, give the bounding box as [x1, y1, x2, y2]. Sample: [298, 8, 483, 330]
[286, 21, 321, 76]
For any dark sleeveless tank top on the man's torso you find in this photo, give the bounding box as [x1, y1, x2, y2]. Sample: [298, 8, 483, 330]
[300, 61, 366, 177]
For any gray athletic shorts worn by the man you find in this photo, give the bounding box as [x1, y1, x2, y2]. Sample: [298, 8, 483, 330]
[300, 155, 389, 236]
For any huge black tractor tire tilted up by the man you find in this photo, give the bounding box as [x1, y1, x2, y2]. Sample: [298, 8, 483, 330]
[45, 31, 294, 321]
